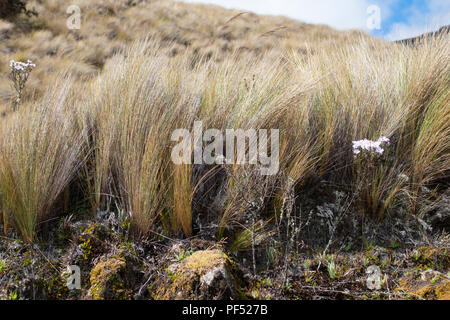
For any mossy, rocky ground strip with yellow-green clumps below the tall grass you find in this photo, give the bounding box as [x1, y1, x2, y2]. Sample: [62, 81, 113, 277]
[0, 210, 450, 300]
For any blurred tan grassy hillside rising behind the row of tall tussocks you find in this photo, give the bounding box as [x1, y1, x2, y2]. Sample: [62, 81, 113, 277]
[0, 0, 382, 111]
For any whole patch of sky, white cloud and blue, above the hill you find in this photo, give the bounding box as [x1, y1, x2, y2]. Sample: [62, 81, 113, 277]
[183, 0, 450, 41]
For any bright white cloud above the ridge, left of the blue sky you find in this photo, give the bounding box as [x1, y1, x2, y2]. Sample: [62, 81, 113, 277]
[179, 0, 373, 30]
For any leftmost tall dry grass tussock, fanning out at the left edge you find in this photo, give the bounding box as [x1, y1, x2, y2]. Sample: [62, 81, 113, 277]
[0, 76, 85, 242]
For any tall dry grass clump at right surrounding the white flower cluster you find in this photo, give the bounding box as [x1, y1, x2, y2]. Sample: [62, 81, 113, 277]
[294, 35, 450, 217]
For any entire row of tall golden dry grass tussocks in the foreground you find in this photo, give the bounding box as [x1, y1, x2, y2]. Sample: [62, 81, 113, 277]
[0, 24, 450, 241]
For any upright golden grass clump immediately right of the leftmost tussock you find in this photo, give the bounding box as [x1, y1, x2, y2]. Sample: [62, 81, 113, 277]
[81, 42, 200, 235]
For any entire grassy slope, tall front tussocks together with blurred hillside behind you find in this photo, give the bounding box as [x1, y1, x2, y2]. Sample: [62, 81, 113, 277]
[0, 0, 450, 300]
